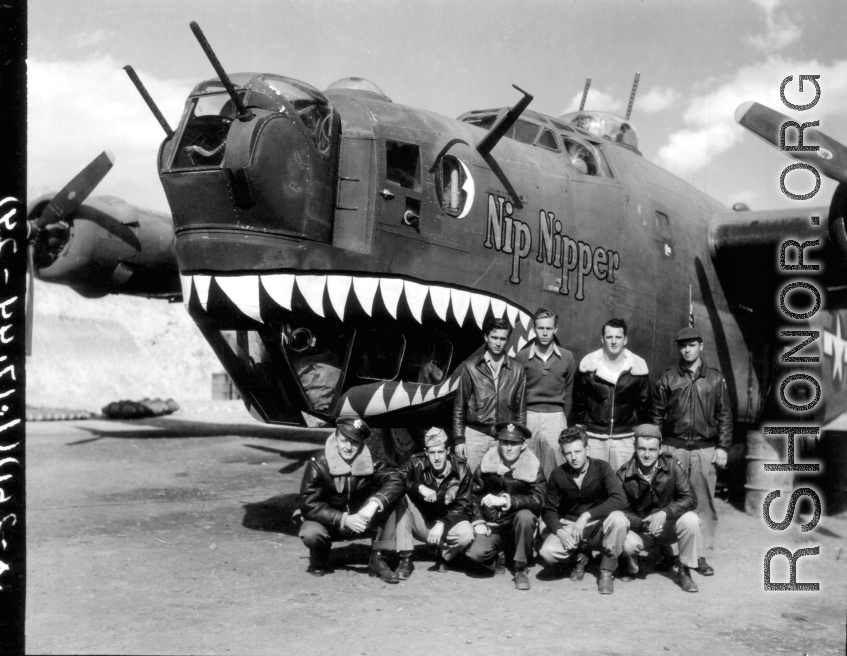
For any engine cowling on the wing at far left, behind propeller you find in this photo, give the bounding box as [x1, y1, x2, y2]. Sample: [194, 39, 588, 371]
[27, 194, 181, 298]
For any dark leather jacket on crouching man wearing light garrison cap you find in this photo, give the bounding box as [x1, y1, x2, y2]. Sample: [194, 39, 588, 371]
[398, 453, 473, 531]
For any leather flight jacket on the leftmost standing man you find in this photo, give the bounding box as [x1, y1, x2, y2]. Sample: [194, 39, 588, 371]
[453, 349, 526, 444]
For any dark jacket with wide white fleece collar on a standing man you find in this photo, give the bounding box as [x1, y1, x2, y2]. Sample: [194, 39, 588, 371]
[573, 349, 652, 437]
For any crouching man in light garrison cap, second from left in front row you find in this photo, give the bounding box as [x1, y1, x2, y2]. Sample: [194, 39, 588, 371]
[397, 427, 473, 579]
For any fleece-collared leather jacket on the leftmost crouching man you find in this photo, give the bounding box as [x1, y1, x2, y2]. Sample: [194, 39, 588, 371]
[300, 433, 406, 528]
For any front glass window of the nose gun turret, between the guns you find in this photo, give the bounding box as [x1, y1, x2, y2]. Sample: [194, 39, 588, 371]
[171, 92, 244, 169]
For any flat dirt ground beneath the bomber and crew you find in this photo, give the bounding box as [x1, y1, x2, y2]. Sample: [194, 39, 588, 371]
[26, 411, 847, 656]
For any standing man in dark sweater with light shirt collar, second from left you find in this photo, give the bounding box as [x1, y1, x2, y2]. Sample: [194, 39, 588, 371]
[515, 308, 576, 479]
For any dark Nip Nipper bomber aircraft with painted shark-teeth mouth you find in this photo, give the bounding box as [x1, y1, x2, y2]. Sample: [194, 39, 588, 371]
[24, 24, 847, 440]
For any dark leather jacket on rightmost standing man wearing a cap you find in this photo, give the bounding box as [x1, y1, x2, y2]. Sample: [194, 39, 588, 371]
[653, 359, 732, 451]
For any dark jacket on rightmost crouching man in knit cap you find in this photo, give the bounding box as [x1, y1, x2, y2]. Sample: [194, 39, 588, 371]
[618, 453, 697, 530]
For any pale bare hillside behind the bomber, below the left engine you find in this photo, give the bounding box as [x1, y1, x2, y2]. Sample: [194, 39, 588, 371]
[27, 281, 222, 411]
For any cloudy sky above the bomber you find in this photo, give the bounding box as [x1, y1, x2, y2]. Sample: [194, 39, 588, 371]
[27, 0, 847, 211]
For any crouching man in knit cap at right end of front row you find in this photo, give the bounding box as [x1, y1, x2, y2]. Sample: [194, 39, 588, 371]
[618, 424, 700, 592]
